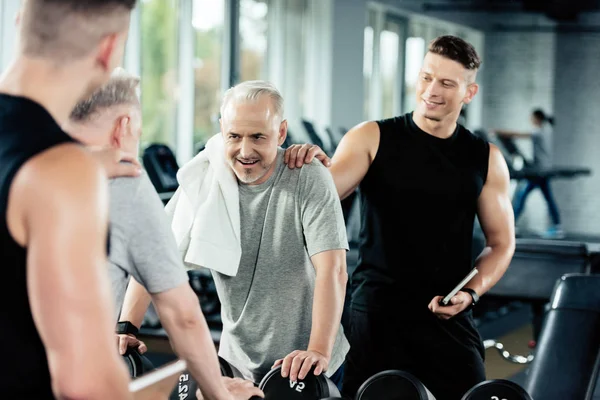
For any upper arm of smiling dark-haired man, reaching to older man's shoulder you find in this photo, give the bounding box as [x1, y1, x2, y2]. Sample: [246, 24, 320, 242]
[329, 122, 379, 199]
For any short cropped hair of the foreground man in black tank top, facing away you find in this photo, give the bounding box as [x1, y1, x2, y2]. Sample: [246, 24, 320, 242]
[21, 0, 137, 61]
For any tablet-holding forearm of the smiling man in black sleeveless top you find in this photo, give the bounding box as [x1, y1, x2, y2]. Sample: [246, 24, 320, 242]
[466, 240, 514, 296]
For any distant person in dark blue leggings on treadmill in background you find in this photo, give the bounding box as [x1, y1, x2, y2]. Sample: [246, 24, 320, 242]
[494, 109, 565, 239]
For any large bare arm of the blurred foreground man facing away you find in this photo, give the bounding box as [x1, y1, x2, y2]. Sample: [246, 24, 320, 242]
[9, 145, 130, 399]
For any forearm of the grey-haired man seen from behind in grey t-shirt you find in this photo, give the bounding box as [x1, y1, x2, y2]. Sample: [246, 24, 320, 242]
[155, 287, 230, 400]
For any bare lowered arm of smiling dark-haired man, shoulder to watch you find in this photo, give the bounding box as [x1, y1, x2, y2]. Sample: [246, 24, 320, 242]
[467, 145, 515, 296]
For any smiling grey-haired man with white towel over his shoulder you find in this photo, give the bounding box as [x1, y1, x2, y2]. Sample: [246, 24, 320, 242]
[119, 81, 348, 386]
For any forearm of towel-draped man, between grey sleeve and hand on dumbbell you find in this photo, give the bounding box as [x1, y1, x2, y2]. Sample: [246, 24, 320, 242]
[308, 265, 348, 358]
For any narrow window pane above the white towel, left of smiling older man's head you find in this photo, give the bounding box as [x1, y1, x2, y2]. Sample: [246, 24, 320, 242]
[192, 0, 225, 148]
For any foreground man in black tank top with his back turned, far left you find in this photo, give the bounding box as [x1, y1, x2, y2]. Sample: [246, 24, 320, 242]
[0, 0, 135, 399]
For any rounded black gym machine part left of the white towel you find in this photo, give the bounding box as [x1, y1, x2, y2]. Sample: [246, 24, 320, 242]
[142, 144, 179, 193]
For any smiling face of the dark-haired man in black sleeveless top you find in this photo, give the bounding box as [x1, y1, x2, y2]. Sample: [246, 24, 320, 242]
[415, 52, 478, 122]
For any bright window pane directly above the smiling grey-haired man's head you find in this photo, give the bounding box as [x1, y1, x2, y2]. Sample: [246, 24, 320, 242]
[239, 0, 268, 82]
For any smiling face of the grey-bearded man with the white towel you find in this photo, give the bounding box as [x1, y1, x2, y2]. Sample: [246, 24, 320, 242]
[221, 96, 287, 185]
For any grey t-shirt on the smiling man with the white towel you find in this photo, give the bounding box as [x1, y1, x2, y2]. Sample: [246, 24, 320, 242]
[212, 149, 349, 382]
